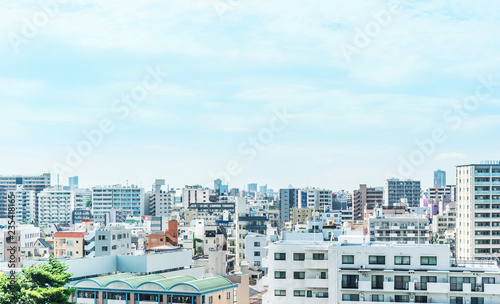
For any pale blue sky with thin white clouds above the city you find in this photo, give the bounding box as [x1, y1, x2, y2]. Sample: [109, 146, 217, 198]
[0, 0, 500, 191]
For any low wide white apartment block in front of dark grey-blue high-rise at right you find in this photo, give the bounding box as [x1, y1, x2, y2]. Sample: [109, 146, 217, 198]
[368, 207, 431, 244]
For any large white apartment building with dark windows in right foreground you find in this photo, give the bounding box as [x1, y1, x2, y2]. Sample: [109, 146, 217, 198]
[263, 239, 500, 304]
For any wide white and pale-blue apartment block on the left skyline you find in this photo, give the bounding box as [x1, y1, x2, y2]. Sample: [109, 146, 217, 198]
[92, 185, 145, 216]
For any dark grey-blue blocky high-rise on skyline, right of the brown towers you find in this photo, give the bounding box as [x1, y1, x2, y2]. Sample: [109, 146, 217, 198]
[384, 178, 421, 207]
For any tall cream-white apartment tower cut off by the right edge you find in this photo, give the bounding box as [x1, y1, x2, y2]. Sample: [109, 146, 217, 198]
[456, 161, 500, 259]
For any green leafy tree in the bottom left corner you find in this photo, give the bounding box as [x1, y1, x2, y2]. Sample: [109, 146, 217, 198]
[0, 256, 75, 304]
